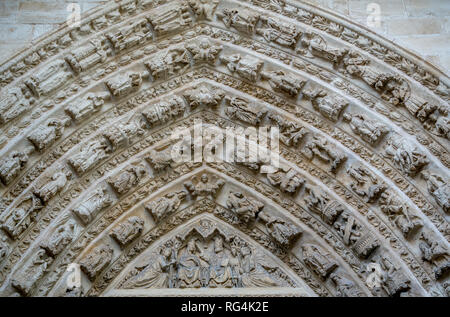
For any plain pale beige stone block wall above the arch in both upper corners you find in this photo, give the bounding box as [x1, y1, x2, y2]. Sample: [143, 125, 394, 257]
[0, 0, 450, 73]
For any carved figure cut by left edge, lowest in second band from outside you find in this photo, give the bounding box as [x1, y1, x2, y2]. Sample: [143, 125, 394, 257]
[0, 147, 34, 185]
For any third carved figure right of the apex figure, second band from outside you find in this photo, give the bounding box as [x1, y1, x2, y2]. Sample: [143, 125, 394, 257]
[303, 89, 348, 122]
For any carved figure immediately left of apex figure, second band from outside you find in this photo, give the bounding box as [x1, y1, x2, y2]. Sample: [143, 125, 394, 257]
[144, 47, 190, 80]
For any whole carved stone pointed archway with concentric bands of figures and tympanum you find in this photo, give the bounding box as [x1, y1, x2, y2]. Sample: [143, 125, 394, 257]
[0, 0, 450, 297]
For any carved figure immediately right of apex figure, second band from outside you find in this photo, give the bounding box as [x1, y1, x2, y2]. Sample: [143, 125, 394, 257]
[219, 54, 264, 82]
